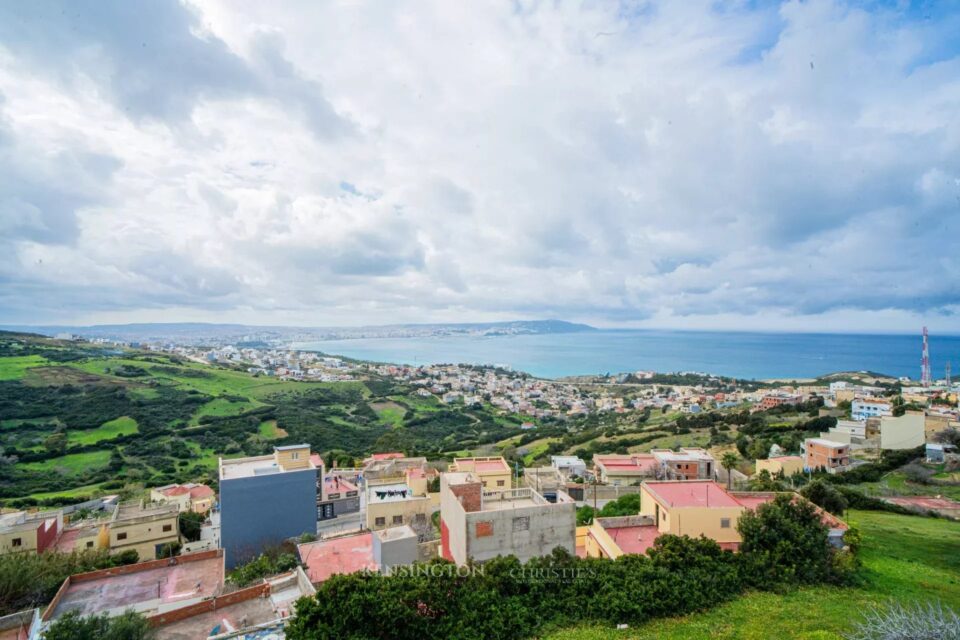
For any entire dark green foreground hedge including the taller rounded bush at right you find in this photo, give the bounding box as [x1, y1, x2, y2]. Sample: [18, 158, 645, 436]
[287, 496, 856, 640]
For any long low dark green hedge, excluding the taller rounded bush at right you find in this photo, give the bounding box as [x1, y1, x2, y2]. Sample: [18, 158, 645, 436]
[286, 535, 742, 640]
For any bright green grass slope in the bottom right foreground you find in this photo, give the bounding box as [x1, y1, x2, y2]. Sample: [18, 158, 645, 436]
[547, 511, 960, 640]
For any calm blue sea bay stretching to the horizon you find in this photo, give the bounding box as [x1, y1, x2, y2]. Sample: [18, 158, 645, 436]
[298, 331, 960, 379]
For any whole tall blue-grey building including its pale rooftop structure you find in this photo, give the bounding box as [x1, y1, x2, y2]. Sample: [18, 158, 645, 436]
[220, 445, 323, 569]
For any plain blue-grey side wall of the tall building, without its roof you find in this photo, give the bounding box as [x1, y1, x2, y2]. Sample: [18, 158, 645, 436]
[220, 467, 317, 568]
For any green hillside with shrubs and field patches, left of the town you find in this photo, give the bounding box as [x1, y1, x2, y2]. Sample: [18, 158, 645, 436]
[0, 333, 520, 502]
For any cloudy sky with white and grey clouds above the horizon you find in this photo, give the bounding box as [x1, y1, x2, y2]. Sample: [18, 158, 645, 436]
[0, 0, 960, 332]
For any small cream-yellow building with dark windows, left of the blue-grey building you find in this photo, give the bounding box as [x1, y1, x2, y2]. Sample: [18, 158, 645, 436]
[108, 503, 180, 561]
